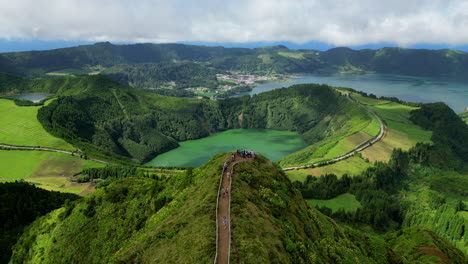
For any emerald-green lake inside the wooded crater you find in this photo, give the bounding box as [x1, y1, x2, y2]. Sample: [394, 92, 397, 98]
[146, 129, 307, 167]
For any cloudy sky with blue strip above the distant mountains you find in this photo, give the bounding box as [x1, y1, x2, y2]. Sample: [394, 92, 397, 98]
[0, 0, 468, 51]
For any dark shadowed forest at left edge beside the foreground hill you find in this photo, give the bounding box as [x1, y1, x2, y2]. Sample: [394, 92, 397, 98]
[0, 182, 79, 263]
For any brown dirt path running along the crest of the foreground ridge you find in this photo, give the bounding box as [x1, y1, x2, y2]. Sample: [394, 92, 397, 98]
[214, 156, 250, 264]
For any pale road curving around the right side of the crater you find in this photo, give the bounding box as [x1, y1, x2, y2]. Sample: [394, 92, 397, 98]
[283, 93, 386, 171]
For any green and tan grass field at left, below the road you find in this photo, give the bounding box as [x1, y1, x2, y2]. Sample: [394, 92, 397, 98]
[0, 150, 105, 194]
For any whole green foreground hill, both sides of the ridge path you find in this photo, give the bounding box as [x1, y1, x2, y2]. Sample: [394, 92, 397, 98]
[10, 154, 464, 263]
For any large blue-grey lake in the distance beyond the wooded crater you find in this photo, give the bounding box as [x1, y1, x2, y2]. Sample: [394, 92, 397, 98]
[249, 74, 468, 113]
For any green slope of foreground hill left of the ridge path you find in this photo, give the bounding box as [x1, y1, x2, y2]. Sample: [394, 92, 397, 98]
[12, 154, 228, 263]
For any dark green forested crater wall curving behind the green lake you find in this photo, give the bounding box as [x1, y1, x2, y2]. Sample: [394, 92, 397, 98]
[13, 71, 370, 162]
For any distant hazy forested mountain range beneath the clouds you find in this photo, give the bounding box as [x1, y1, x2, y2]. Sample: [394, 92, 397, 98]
[0, 42, 468, 78]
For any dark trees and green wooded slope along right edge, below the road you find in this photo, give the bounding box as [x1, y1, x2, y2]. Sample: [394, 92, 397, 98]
[295, 100, 468, 252]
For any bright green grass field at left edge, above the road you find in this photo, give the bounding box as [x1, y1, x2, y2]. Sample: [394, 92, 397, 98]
[0, 99, 75, 150]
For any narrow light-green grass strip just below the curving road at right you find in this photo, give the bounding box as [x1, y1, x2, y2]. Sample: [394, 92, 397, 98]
[286, 156, 372, 182]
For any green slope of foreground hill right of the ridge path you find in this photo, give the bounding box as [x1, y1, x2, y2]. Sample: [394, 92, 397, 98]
[231, 158, 388, 263]
